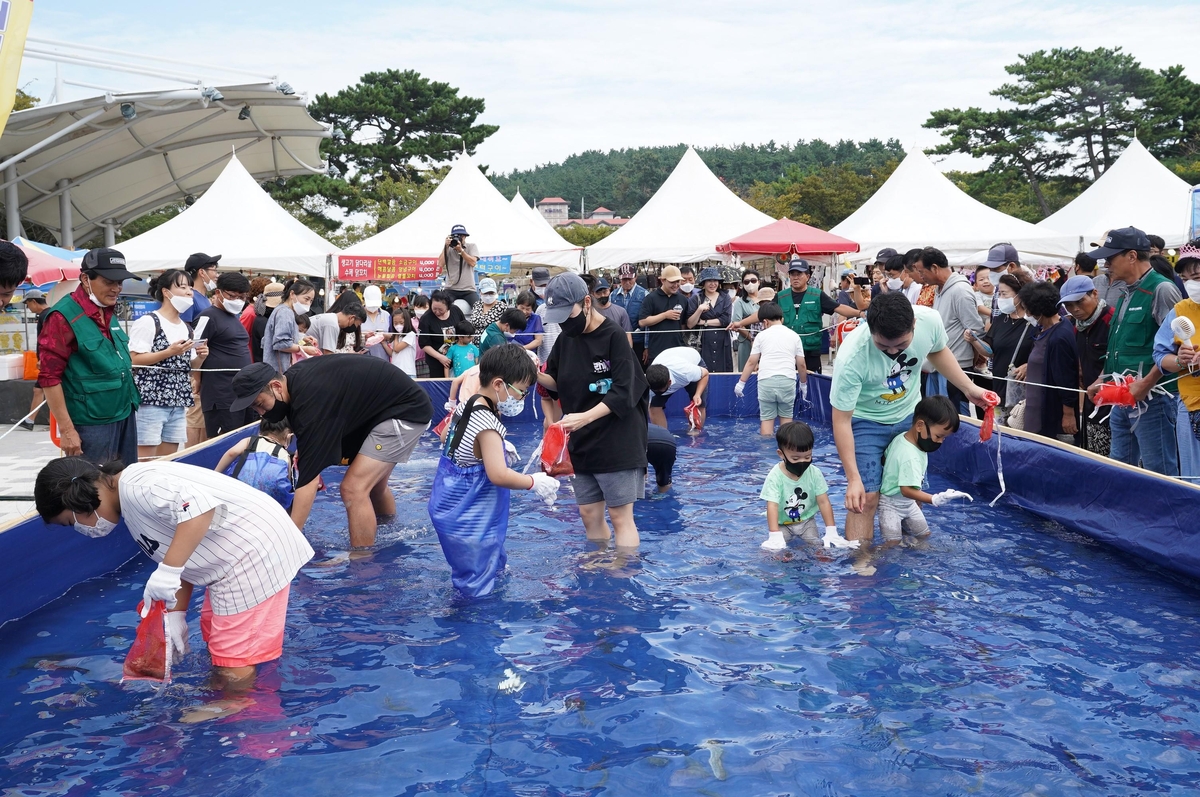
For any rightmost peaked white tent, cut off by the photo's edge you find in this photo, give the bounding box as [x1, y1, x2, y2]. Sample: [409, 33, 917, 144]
[1038, 139, 1192, 246]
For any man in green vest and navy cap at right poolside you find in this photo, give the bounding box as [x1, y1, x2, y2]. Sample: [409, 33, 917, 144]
[1087, 227, 1182, 477]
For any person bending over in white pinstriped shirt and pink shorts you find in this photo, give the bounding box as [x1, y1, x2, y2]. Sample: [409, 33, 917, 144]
[34, 456, 313, 690]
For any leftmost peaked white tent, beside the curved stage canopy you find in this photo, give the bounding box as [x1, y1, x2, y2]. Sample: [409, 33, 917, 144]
[116, 156, 337, 277]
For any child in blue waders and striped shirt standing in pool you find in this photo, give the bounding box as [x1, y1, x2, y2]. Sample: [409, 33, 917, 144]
[428, 344, 559, 598]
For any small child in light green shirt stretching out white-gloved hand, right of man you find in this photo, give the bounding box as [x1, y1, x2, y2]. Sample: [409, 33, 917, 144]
[880, 396, 974, 545]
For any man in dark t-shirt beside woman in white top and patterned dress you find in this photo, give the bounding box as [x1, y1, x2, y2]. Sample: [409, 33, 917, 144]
[197, 271, 254, 438]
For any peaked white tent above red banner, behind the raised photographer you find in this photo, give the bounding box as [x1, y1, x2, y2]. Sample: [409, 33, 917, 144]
[346, 154, 580, 271]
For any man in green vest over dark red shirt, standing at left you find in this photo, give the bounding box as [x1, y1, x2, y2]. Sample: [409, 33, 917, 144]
[37, 248, 142, 465]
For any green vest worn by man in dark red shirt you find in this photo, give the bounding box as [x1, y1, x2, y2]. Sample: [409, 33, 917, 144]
[54, 296, 140, 426]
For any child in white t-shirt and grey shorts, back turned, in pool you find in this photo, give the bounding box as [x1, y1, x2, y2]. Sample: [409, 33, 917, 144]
[733, 302, 809, 437]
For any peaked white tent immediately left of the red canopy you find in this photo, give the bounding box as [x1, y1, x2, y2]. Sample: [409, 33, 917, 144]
[588, 146, 775, 269]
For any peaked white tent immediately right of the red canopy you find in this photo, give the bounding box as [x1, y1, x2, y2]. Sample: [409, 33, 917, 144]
[829, 149, 1079, 265]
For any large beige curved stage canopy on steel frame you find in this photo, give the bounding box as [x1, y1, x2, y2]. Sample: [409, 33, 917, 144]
[0, 83, 331, 248]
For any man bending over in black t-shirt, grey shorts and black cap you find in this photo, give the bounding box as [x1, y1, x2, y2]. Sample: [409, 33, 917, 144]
[226, 354, 433, 547]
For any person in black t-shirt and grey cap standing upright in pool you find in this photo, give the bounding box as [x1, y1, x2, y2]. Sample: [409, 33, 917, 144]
[538, 273, 648, 549]
